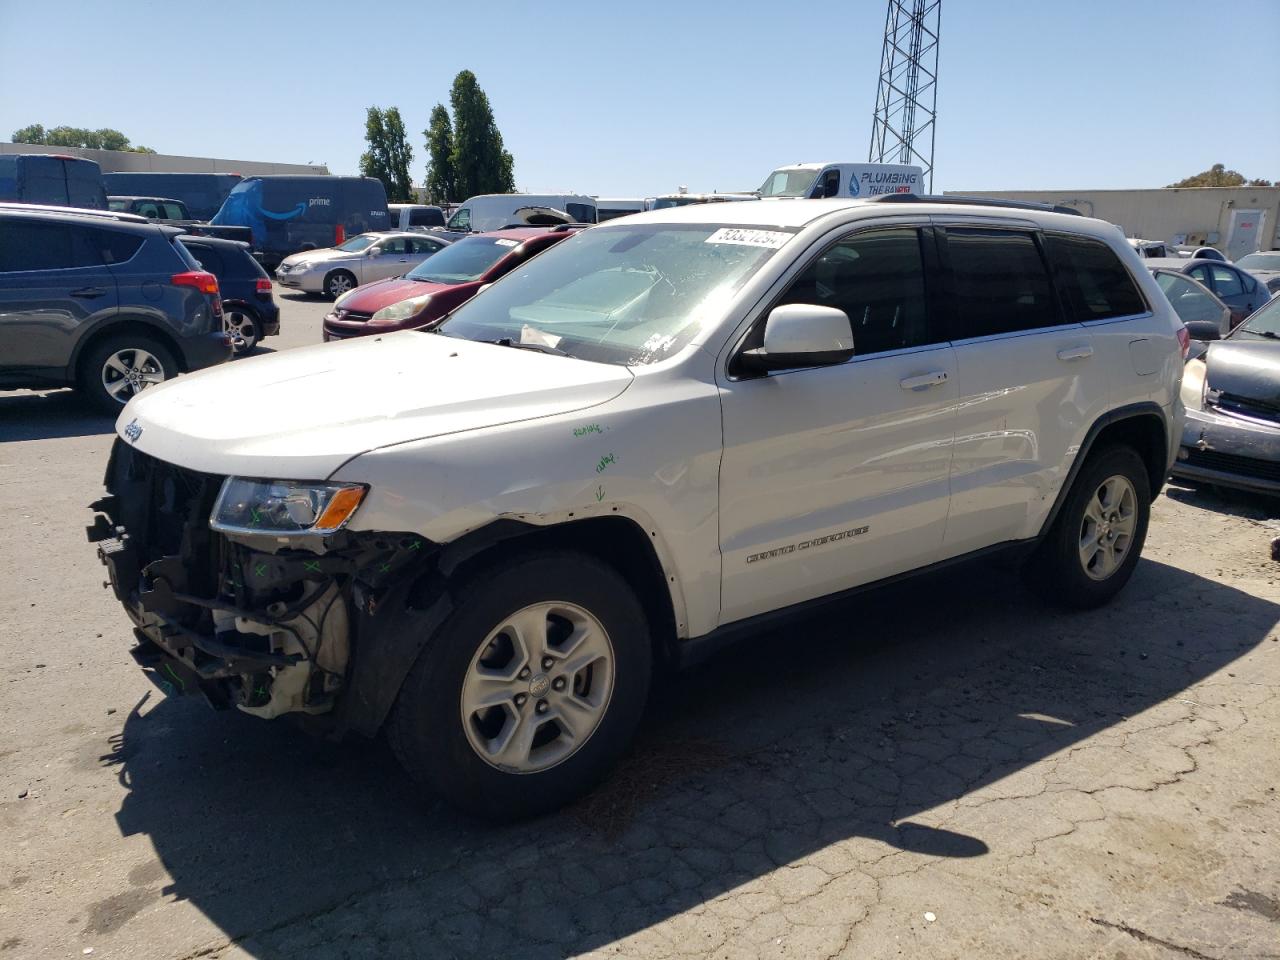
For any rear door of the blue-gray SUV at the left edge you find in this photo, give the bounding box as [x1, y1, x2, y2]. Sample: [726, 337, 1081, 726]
[0, 218, 119, 375]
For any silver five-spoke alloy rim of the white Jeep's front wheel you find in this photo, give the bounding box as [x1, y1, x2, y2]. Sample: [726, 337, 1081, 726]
[461, 602, 614, 773]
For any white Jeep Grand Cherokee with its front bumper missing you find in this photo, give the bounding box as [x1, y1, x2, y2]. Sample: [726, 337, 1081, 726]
[90, 197, 1187, 818]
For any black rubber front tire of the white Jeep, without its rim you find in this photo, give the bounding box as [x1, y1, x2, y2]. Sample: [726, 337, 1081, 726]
[387, 552, 653, 822]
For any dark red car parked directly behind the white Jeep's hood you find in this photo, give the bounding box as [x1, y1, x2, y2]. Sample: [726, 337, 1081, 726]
[324, 227, 572, 340]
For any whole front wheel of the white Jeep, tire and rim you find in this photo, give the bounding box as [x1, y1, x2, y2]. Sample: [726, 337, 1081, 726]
[388, 553, 652, 820]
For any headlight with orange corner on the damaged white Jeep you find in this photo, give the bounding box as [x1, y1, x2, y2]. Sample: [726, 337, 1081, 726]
[209, 476, 369, 535]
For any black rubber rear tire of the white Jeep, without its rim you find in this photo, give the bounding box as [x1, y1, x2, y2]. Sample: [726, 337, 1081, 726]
[1027, 447, 1151, 609]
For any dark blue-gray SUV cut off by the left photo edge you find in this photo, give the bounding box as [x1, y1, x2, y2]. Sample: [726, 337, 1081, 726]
[0, 204, 232, 412]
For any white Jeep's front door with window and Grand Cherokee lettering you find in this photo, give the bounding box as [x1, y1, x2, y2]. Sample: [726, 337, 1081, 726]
[719, 224, 957, 623]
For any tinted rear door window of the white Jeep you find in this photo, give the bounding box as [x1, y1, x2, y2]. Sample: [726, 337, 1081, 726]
[946, 227, 1062, 340]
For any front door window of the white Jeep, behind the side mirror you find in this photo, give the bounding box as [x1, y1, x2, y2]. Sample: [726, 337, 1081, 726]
[780, 229, 937, 356]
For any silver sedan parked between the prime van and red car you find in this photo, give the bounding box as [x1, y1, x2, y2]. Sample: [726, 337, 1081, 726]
[275, 232, 449, 300]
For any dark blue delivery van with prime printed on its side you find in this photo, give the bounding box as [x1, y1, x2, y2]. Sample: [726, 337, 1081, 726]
[210, 175, 389, 268]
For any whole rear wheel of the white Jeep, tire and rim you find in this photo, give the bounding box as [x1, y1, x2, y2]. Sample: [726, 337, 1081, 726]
[1028, 447, 1151, 609]
